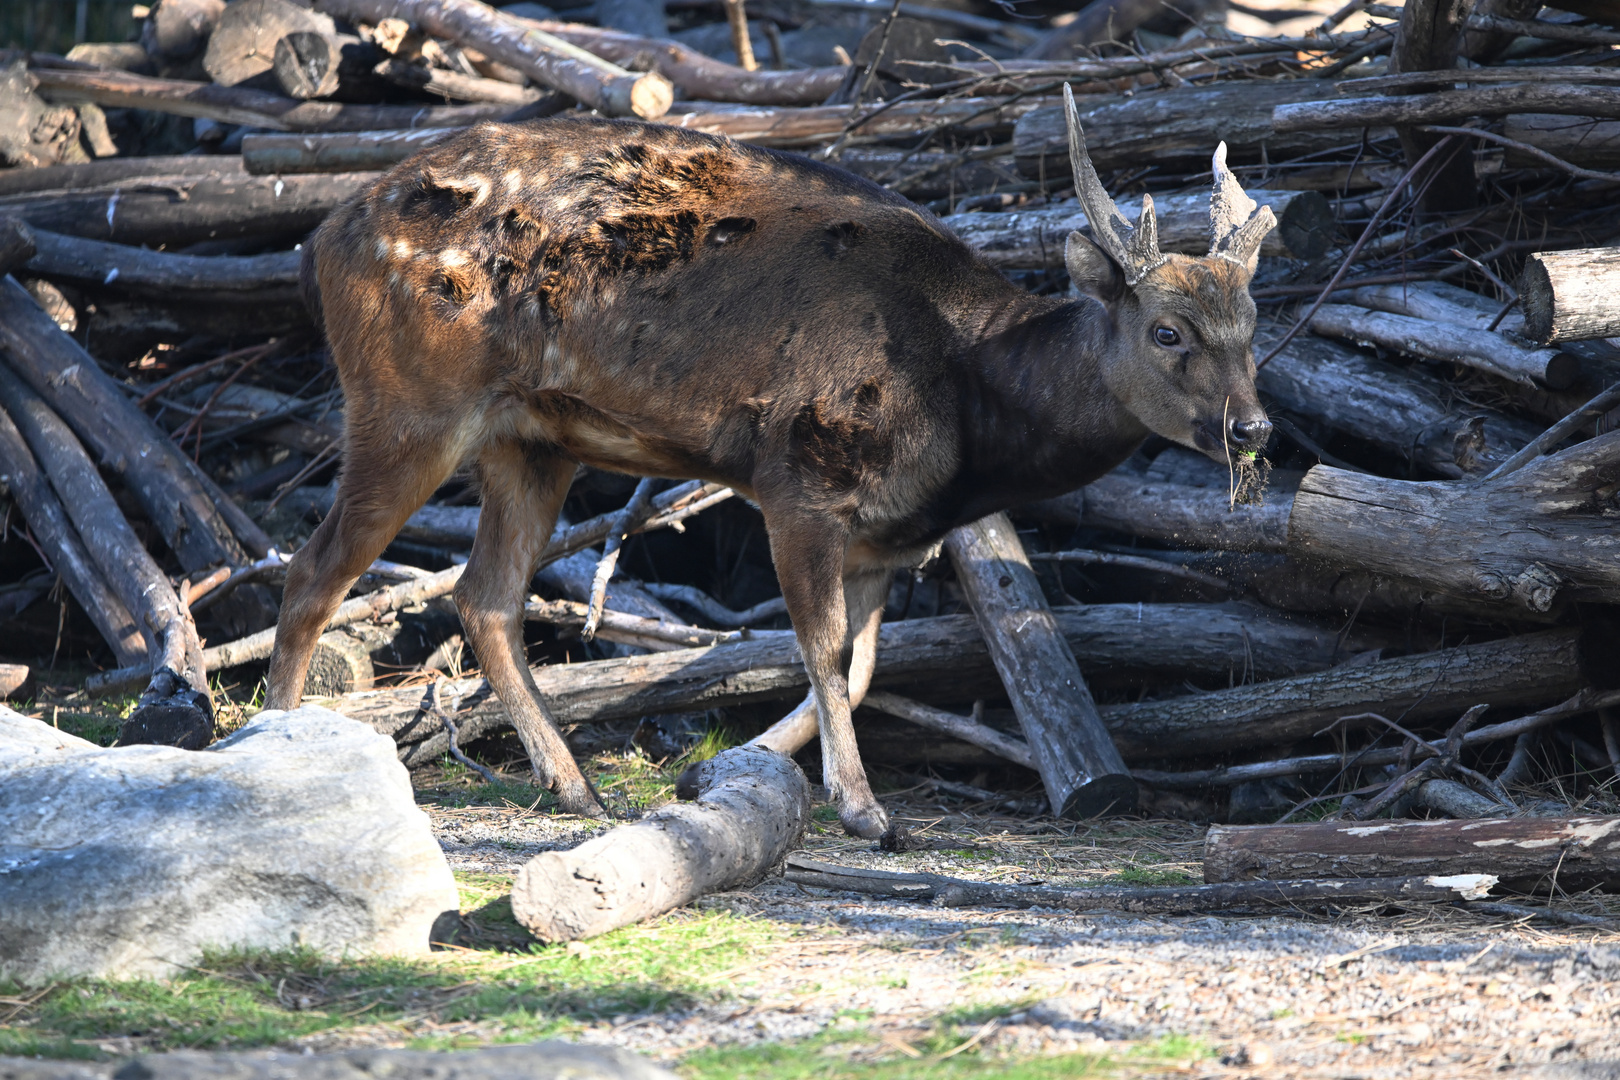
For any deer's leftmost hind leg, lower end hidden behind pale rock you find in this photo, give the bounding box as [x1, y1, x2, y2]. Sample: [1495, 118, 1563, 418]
[264, 433, 460, 709]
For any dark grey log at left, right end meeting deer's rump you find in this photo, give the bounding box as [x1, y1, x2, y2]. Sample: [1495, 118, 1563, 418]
[28, 228, 301, 303]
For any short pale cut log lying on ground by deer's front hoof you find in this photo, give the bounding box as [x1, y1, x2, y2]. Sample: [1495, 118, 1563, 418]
[512, 746, 810, 942]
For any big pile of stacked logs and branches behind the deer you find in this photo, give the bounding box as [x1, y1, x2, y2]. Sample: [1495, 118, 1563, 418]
[0, 0, 1620, 819]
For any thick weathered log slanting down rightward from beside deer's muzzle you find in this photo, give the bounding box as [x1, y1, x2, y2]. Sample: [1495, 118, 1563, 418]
[1256, 325, 1541, 479]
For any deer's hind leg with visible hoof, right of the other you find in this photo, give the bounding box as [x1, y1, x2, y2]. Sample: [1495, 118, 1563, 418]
[455, 439, 604, 818]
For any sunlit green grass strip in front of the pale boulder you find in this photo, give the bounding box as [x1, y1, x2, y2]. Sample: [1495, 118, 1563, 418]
[0, 906, 789, 1057]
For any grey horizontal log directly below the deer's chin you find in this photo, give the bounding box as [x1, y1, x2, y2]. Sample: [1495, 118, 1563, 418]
[1022, 470, 1290, 552]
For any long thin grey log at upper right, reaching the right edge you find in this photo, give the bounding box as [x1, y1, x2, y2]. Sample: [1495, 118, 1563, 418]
[1272, 83, 1620, 136]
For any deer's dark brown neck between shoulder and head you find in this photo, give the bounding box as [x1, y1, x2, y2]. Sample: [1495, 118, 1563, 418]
[962, 296, 1149, 517]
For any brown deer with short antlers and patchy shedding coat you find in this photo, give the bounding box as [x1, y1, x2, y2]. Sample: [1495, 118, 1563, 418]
[266, 86, 1275, 837]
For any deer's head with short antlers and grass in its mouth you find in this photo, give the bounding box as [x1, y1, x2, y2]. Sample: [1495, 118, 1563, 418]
[1063, 86, 1277, 463]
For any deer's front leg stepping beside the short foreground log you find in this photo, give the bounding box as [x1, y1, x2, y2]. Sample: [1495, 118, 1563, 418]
[761, 500, 889, 839]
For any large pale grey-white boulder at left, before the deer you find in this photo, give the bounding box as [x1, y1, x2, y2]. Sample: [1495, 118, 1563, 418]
[0, 706, 457, 983]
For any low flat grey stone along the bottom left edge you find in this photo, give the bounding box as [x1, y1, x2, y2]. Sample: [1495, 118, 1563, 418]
[0, 1043, 676, 1080]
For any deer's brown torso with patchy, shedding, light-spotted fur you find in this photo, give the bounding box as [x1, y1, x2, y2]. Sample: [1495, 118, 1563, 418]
[314, 120, 1017, 531]
